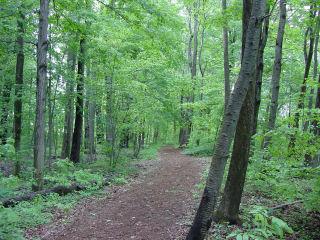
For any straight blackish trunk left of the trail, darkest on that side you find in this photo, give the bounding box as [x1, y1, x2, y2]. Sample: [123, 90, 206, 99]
[70, 38, 85, 163]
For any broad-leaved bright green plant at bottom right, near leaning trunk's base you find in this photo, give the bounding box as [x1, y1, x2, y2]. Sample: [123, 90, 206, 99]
[227, 206, 293, 240]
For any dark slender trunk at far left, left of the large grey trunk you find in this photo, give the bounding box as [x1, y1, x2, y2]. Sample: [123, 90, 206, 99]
[13, 6, 25, 176]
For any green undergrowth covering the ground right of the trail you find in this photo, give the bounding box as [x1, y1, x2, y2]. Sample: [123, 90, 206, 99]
[184, 141, 320, 240]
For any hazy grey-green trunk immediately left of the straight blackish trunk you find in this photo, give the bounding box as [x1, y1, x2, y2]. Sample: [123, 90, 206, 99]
[61, 49, 77, 158]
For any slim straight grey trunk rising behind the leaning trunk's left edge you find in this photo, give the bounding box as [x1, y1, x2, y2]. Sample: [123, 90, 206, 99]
[222, 0, 230, 111]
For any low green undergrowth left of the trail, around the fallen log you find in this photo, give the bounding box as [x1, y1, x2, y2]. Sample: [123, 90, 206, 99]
[0, 144, 161, 240]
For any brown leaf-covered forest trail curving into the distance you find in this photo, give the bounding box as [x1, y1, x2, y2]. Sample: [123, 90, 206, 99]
[26, 146, 208, 240]
